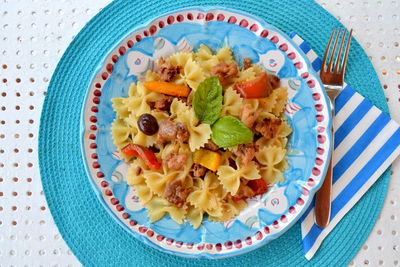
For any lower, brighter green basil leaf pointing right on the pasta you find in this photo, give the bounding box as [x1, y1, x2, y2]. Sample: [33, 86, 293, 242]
[211, 116, 253, 148]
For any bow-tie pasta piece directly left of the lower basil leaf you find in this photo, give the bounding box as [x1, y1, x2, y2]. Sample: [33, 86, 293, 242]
[171, 99, 211, 152]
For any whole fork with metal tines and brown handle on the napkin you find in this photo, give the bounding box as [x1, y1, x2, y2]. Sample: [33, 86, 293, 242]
[314, 28, 353, 228]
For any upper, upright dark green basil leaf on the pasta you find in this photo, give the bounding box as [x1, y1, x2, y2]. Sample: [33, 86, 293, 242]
[193, 77, 223, 124]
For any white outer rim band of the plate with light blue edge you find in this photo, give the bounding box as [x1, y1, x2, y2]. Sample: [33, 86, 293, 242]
[80, 6, 332, 259]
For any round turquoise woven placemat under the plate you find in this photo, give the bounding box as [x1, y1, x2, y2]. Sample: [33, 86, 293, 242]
[39, 0, 389, 267]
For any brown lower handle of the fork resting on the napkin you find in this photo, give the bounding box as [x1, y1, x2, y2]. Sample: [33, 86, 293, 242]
[314, 150, 332, 228]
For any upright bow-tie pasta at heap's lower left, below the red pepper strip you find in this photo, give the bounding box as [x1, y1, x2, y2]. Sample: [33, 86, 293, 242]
[127, 158, 154, 205]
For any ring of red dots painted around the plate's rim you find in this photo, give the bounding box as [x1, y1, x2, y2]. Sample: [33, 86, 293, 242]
[84, 9, 326, 252]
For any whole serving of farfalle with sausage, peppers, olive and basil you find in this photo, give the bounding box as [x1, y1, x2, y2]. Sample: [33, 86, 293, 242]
[111, 45, 291, 228]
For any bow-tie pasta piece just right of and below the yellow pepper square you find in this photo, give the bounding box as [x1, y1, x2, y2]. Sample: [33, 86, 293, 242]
[217, 161, 261, 195]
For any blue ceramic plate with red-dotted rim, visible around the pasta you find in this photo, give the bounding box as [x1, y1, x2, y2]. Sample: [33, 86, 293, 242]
[81, 7, 331, 258]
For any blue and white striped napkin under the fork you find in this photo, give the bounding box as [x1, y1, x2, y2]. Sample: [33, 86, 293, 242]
[290, 33, 400, 260]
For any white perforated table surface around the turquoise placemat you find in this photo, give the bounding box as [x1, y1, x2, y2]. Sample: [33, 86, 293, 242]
[0, 0, 400, 267]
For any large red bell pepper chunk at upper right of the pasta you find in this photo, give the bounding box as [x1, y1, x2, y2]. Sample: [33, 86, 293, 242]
[233, 72, 273, 98]
